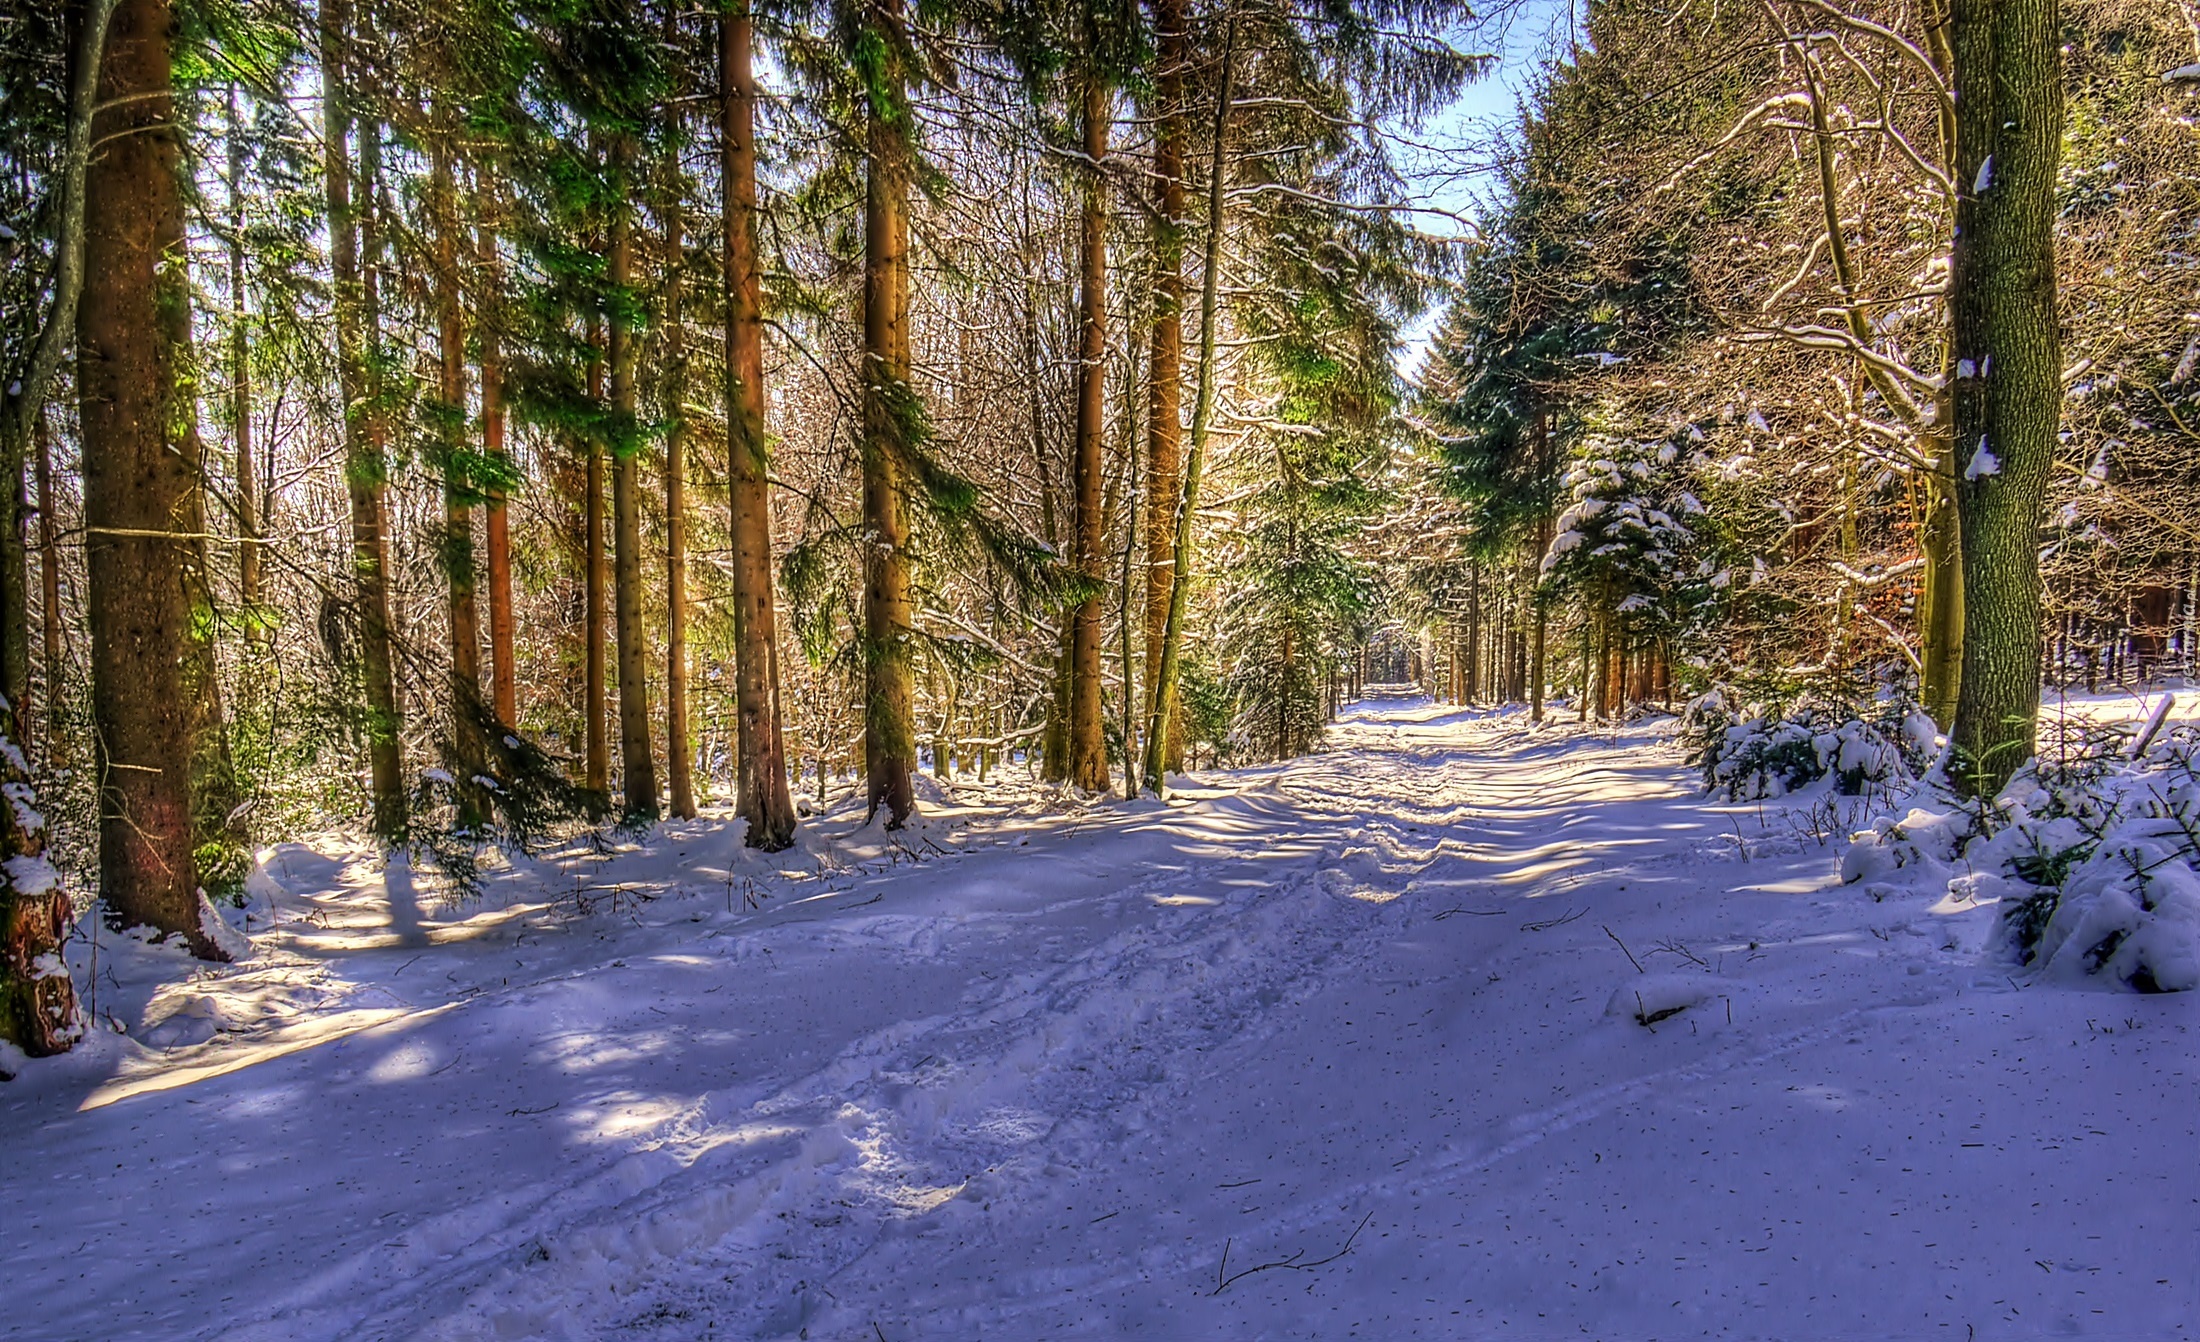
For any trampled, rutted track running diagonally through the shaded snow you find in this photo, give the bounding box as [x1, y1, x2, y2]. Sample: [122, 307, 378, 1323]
[392, 752, 1443, 1342]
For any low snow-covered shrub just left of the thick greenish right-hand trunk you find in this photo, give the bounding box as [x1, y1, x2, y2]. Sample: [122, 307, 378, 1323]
[1681, 691, 1934, 801]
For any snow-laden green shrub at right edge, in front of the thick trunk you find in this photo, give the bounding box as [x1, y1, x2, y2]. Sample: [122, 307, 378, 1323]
[1841, 728, 2200, 992]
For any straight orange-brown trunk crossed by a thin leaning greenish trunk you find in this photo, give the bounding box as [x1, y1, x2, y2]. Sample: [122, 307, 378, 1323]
[1146, 0, 1188, 770]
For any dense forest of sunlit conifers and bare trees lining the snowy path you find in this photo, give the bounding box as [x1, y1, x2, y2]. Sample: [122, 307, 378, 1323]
[0, 0, 2200, 1052]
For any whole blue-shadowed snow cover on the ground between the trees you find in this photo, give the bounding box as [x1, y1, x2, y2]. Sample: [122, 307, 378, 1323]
[0, 700, 2200, 1342]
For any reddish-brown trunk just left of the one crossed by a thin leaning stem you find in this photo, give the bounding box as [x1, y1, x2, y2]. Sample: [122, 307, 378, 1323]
[1069, 73, 1109, 792]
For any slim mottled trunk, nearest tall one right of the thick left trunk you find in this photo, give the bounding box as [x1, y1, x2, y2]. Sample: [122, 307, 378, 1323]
[321, 0, 405, 843]
